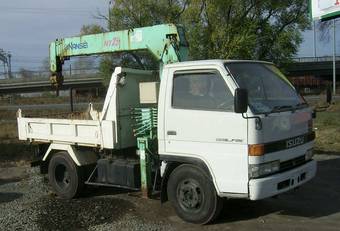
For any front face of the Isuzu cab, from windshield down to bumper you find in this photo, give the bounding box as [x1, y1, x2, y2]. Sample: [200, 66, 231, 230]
[226, 62, 316, 200]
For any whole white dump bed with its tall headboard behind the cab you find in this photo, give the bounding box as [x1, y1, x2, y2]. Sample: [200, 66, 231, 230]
[17, 67, 158, 149]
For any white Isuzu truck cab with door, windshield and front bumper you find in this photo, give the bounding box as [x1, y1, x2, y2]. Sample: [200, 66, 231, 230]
[158, 60, 316, 220]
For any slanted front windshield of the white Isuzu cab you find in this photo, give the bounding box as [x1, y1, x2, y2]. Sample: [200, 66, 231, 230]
[225, 62, 307, 114]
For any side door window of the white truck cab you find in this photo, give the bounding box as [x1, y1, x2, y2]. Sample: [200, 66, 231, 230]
[172, 71, 234, 111]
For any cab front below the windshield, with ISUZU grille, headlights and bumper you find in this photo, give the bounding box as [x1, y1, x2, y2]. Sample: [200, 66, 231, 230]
[248, 111, 316, 200]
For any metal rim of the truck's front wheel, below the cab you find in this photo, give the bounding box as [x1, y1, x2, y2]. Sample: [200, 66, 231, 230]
[177, 179, 204, 212]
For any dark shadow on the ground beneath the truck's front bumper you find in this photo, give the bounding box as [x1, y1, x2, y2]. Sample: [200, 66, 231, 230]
[217, 159, 340, 223]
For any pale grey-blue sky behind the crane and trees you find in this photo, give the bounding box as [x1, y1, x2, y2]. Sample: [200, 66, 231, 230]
[0, 0, 340, 72]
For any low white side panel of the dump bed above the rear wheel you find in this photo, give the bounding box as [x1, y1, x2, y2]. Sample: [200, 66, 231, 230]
[17, 113, 115, 149]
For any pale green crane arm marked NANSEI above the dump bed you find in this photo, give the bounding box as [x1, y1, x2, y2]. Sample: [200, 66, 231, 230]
[50, 24, 188, 88]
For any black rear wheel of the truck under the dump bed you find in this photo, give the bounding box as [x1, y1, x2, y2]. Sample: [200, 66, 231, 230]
[48, 152, 84, 199]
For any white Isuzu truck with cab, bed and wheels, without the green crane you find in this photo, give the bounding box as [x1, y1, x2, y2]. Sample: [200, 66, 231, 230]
[17, 23, 316, 224]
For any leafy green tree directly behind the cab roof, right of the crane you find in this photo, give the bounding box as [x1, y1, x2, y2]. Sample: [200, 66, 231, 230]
[184, 0, 309, 64]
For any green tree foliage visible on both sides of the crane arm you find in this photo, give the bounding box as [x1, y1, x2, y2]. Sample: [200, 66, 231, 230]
[81, 0, 309, 81]
